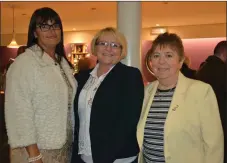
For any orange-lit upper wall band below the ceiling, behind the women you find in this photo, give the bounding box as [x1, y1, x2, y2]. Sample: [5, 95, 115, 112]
[0, 23, 226, 46]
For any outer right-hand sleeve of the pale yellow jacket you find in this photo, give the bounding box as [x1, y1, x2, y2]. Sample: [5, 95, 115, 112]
[200, 86, 224, 163]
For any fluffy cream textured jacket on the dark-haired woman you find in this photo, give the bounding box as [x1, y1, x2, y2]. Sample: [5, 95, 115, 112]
[5, 45, 77, 149]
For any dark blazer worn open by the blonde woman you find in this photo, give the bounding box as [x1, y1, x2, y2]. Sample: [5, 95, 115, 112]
[71, 63, 144, 163]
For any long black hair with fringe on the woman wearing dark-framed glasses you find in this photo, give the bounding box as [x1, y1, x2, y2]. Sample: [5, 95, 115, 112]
[27, 7, 73, 68]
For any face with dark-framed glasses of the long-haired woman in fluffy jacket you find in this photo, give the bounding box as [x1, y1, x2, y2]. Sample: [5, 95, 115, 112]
[34, 20, 61, 48]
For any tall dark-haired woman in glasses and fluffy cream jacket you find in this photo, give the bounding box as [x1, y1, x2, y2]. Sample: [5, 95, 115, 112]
[5, 8, 77, 163]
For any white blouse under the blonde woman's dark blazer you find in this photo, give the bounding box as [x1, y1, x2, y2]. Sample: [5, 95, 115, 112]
[78, 64, 136, 163]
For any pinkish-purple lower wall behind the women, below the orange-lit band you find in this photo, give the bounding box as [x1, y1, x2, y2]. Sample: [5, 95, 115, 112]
[0, 37, 226, 82]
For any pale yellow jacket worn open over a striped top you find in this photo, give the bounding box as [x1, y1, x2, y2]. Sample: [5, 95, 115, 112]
[137, 73, 224, 163]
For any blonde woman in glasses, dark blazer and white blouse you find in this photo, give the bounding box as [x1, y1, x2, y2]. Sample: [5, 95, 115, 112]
[72, 28, 144, 163]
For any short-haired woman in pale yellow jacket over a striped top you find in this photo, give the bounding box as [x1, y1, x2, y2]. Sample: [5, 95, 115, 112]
[137, 33, 224, 163]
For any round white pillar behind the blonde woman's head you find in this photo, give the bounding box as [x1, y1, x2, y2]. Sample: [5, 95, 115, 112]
[117, 2, 142, 69]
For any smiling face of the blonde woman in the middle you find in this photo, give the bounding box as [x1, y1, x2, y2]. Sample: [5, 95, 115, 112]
[95, 33, 122, 66]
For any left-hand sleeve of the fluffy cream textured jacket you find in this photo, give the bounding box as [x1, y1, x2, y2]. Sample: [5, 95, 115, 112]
[5, 56, 36, 148]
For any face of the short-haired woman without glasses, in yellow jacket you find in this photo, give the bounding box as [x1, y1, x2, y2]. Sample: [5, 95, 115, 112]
[150, 46, 183, 80]
